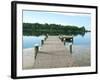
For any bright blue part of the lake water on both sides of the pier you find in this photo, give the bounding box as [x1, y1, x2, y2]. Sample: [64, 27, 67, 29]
[23, 33, 91, 48]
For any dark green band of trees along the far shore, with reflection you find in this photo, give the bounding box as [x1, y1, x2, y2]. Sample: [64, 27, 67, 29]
[23, 23, 87, 35]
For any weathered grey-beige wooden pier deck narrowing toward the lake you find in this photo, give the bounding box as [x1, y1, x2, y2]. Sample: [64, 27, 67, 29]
[33, 36, 76, 68]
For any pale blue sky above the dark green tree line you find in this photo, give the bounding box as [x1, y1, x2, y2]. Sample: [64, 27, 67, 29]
[23, 10, 91, 30]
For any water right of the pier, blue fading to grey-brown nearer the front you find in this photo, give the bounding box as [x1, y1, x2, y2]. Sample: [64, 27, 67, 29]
[65, 33, 91, 66]
